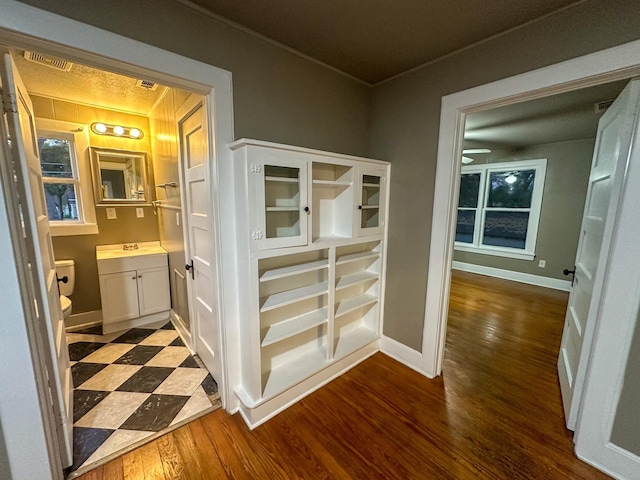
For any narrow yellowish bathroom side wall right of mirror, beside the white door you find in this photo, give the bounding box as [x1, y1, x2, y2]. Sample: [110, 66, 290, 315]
[149, 88, 189, 325]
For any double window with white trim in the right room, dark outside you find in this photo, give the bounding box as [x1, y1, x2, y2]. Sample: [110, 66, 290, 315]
[455, 159, 547, 260]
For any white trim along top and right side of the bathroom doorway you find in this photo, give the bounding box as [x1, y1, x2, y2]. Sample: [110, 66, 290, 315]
[0, 0, 239, 476]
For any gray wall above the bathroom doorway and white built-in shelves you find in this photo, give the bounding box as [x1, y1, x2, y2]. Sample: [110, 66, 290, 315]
[17, 0, 370, 155]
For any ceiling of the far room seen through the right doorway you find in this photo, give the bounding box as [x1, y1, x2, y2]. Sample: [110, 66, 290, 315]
[464, 80, 628, 149]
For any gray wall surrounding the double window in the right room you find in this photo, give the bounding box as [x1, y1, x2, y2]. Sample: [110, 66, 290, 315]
[453, 140, 595, 280]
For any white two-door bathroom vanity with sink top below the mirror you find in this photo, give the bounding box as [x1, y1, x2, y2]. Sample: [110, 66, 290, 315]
[96, 242, 171, 334]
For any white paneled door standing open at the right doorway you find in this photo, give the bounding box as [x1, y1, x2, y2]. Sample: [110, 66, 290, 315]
[558, 80, 640, 430]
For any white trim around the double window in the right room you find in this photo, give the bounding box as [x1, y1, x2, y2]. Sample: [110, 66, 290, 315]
[454, 158, 547, 260]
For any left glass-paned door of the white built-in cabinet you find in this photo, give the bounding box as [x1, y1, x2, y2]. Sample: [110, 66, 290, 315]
[250, 158, 309, 250]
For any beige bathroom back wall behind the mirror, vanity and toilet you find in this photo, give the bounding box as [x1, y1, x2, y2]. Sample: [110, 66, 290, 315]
[31, 95, 159, 314]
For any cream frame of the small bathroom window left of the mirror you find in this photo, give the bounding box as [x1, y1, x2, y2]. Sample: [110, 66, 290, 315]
[35, 118, 98, 237]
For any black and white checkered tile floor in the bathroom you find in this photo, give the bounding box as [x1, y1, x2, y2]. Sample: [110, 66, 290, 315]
[67, 322, 220, 471]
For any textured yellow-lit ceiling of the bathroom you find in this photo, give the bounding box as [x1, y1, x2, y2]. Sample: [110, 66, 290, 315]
[12, 50, 165, 115]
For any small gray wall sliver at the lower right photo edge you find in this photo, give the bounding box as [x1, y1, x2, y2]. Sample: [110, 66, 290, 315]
[611, 312, 640, 455]
